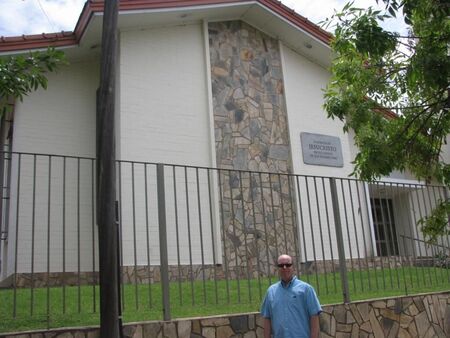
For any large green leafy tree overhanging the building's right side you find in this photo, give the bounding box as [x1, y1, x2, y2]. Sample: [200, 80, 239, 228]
[324, 0, 450, 242]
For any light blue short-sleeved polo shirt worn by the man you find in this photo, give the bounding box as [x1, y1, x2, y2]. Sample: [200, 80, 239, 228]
[261, 276, 322, 338]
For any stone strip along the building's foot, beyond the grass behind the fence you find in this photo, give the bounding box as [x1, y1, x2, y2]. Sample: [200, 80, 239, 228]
[0, 256, 442, 288]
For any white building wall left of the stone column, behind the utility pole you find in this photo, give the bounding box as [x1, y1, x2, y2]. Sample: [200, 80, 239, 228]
[0, 24, 220, 282]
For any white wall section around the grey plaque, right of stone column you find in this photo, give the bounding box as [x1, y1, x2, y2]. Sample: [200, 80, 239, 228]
[280, 44, 372, 260]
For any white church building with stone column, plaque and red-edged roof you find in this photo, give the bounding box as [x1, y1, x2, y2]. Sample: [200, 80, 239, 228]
[0, 0, 449, 286]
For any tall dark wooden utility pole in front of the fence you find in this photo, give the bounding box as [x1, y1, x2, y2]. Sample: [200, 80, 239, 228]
[97, 0, 121, 338]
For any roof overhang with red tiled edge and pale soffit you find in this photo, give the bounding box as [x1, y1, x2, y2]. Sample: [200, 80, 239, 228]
[0, 0, 331, 67]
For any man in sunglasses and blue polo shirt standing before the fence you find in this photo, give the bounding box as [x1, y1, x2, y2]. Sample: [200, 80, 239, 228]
[261, 255, 322, 338]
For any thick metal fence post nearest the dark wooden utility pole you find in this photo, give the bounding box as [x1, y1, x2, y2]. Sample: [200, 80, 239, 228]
[156, 163, 170, 320]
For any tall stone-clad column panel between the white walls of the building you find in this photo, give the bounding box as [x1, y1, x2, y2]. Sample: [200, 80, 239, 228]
[208, 21, 298, 277]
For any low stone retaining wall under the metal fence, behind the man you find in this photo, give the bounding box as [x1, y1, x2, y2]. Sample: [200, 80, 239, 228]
[0, 292, 450, 338]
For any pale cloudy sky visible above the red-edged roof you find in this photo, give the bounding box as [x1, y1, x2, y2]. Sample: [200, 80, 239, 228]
[0, 0, 404, 36]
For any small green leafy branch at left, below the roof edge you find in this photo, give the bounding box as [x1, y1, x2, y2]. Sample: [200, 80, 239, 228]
[0, 48, 65, 116]
